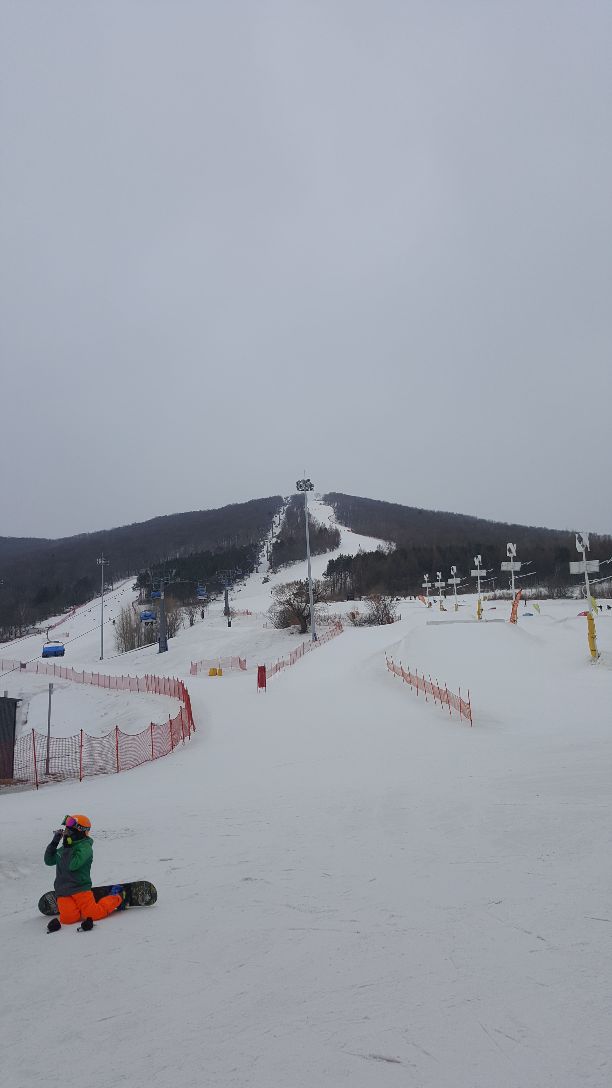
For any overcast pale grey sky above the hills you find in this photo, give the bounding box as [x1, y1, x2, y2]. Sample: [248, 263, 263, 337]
[0, 0, 612, 536]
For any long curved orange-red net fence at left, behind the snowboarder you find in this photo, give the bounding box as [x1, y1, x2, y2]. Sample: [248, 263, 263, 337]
[0, 660, 196, 789]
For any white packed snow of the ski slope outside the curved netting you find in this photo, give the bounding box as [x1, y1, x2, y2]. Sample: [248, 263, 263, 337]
[0, 504, 612, 1088]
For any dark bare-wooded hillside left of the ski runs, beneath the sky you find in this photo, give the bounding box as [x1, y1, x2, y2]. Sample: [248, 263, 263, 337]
[0, 495, 283, 638]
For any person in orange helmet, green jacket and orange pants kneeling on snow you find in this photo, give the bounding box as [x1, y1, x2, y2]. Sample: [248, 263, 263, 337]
[45, 815, 126, 934]
